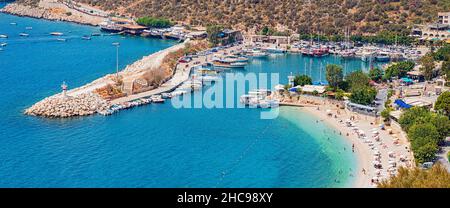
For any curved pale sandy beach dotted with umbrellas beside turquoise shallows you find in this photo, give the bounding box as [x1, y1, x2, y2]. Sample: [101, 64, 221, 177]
[286, 97, 413, 188]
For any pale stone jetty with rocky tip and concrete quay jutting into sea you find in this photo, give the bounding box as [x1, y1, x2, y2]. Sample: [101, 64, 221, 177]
[24, 41, 190, 118]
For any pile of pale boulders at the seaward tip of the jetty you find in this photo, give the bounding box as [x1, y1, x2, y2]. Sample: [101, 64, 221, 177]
[25, 93, 110, 118]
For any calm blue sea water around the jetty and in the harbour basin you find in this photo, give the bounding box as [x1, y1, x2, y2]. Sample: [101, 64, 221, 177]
[0, 2, 361, 187]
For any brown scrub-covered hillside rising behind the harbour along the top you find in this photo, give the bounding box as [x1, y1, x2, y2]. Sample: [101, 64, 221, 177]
[11, 0, 450, 34]
